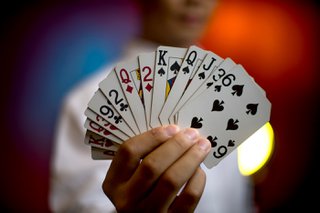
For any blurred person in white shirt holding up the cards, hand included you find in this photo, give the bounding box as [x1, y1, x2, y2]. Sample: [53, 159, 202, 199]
[50, 0, 254, 213]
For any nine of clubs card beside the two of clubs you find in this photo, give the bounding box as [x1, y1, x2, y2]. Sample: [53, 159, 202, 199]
[88, 89, 135, 137]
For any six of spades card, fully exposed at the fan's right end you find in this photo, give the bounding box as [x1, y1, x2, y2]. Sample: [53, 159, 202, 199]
[178, 65, 271, 168]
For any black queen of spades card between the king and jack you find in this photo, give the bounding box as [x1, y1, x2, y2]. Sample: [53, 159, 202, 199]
[159, 46, 207, 125]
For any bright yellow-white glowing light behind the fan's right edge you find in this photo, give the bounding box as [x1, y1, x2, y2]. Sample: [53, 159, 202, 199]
[238, 122, 274, 176]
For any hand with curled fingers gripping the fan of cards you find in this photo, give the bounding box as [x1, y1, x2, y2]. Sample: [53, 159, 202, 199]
[102, 125, 211, 212]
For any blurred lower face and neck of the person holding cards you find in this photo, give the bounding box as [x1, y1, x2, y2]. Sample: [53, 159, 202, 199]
[142, 0, 215, 46]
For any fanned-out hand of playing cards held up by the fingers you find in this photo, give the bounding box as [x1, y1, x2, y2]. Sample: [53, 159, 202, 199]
[84, 46, 271, 168]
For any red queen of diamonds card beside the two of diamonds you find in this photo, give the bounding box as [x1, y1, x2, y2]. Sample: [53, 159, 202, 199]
[115, 57, 147, 133]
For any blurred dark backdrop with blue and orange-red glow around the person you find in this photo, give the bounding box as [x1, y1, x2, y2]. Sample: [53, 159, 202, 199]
[0, 0, 320, 212]
